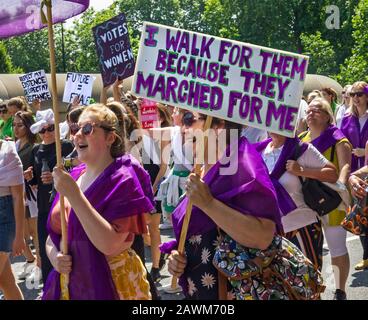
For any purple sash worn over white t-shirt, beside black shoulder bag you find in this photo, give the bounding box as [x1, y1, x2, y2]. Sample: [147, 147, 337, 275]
[254, 138, 308, 216]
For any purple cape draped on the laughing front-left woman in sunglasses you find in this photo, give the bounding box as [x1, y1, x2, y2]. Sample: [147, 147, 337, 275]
[43, 156, 154, 300]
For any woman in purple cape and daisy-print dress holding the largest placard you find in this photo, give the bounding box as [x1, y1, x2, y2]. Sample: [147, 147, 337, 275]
[162, 114, 281, 300]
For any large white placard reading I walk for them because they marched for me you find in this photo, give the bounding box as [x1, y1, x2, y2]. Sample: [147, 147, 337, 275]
[132, 22, 309, 137]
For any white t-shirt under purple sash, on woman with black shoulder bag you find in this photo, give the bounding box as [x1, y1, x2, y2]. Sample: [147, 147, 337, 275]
[262, 144, 328, 232]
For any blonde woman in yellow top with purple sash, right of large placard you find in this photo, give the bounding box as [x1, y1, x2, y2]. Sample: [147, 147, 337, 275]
[299, 98, 351, 300]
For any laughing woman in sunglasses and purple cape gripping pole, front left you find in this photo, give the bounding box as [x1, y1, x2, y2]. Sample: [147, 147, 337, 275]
[43, 105, 153, 300]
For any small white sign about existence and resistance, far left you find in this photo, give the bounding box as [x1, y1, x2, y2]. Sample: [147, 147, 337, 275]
[19, 70, 51, 103]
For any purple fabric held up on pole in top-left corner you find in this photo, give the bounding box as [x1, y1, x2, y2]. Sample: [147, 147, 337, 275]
[0, 0, 89, 39]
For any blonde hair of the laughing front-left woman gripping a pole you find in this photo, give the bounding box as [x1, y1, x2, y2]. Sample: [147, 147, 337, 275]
[81, 103, 125, 158]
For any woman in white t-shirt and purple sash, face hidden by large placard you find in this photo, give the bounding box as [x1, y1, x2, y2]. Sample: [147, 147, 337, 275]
[255, 133, 337, 270]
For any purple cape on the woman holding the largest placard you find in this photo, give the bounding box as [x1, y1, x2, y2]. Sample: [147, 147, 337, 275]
[171, 137, 281, 244]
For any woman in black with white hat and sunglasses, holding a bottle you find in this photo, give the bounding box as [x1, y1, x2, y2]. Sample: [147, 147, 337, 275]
[25, 109, 73, 282]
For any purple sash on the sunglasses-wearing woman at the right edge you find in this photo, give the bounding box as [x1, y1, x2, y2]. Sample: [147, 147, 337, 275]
[341, 114, 368, 172]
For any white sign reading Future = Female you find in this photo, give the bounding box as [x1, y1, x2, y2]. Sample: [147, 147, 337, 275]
[63, 72, 96, 106]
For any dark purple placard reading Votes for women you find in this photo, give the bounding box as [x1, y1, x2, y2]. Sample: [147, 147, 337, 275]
[93, 13, 134, 87]
